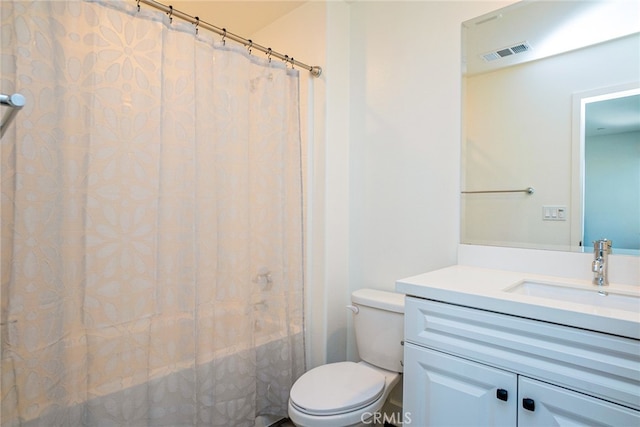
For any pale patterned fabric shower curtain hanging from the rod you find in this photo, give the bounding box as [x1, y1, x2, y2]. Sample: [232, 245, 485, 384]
[0, 0, 304, 427]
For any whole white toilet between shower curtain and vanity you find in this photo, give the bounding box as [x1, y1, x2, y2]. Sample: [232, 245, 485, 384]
[289, 289, 404, 427]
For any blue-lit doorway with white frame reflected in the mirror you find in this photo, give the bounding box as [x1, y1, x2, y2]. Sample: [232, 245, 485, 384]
[580, 88, 640, 253]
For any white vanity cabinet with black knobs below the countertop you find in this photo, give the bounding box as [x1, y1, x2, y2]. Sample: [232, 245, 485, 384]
[403, 297, 640, 427]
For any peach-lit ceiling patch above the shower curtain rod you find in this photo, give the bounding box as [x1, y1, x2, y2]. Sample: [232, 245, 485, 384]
[165, 0, 305, 36]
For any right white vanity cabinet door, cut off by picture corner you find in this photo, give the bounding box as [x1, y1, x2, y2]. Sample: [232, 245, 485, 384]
[518, 377, 640, 427]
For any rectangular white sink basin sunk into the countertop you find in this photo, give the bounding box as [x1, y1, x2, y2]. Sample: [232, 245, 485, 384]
[504, 280, 640, 313]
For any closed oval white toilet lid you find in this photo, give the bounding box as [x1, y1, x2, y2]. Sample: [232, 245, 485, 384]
[290, 362, 385, 415]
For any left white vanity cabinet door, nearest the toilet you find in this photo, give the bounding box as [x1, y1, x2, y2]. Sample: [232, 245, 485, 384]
[403, 343, 518, 427]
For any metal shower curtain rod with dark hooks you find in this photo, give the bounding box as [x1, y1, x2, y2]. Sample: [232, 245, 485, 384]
[136, 0, 322, 77]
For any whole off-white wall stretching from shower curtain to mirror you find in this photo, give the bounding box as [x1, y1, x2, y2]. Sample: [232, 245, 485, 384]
[254, 1, 512, 367]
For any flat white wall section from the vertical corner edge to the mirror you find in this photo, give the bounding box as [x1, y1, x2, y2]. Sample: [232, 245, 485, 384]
[348, 1, 507, 359]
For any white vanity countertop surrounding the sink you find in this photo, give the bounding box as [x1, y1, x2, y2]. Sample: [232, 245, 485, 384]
[396, 265, 640, 339]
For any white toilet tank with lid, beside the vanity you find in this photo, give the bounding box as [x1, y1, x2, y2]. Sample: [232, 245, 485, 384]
[351, 289, 404, 372]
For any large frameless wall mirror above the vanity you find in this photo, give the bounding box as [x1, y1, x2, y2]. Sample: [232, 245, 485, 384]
[461, 0, 640, 254]
